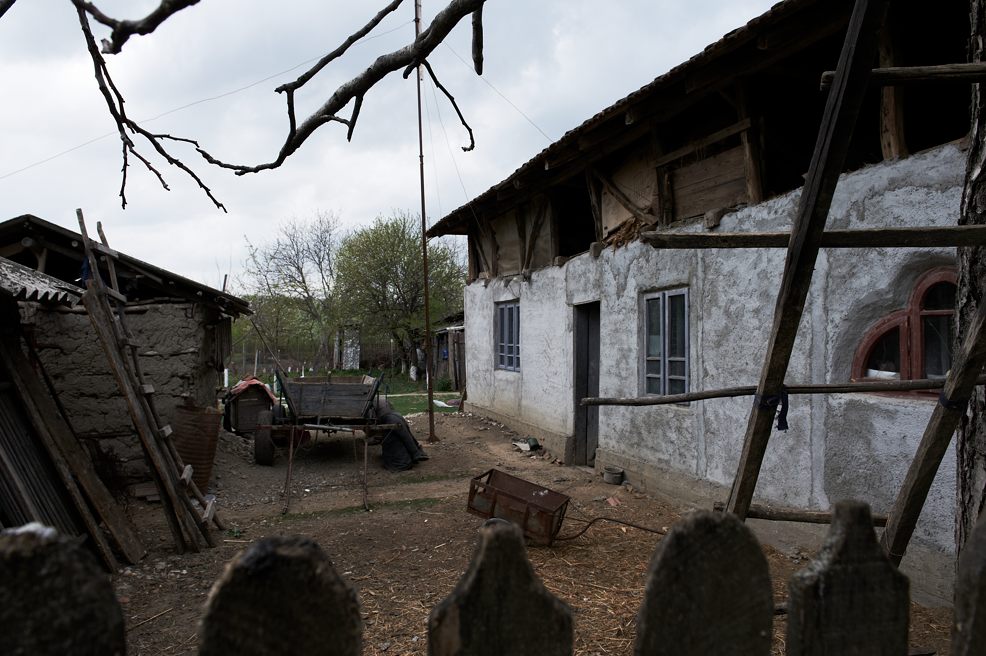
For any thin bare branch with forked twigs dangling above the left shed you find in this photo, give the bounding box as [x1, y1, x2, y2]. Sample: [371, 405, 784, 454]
[72, 0, 226, 212]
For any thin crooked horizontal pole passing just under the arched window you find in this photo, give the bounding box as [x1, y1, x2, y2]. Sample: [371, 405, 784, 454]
[582, 375, 986, 406]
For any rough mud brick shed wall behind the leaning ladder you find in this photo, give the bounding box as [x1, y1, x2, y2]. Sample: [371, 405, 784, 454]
[23, 303, 229, 486]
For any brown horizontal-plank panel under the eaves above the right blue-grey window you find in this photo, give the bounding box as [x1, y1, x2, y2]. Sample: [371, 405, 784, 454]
[672, 146, 749, 220]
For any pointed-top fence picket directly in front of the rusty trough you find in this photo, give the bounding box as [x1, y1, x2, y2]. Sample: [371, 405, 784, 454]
[428, 520, 573, 656]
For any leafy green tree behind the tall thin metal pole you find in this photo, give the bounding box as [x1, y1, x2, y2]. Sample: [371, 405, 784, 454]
[336, 211, 465, 370]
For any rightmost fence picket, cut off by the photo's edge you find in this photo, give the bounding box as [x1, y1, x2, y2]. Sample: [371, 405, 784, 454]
[952, 515, 986, 656]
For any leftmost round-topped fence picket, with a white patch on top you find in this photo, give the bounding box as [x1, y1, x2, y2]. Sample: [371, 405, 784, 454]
[0, 524, 126, 656]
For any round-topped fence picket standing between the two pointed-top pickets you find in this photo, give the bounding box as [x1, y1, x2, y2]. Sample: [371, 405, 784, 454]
[634, 511, 774, 656]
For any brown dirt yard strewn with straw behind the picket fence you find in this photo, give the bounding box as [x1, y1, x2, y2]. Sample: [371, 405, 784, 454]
[113, 414, 951, 656]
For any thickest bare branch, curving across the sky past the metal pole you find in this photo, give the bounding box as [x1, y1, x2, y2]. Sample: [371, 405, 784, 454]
[192, 0, 486, 175]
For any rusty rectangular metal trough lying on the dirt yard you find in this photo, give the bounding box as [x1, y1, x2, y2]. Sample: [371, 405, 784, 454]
[467, 469, 569, 546]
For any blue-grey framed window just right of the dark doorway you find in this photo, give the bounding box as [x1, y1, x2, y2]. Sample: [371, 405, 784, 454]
[641, 288, 688, 395]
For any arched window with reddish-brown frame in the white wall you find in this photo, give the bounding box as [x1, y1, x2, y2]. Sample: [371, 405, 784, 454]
[852, 268, 956, 380]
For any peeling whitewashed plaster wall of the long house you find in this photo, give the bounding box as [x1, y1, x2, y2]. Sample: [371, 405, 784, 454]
[465, 146, 964, 564]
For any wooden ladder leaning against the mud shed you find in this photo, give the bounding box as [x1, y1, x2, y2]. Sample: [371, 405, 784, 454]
[76, 209, 225, 552]
